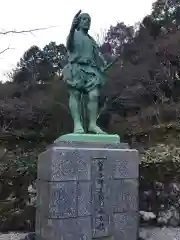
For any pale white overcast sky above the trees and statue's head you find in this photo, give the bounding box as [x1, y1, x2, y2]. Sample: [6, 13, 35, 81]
[0, 0, 154, 81]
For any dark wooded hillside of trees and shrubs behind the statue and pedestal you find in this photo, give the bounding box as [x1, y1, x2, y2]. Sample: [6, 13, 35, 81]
[0, 0, 180, 231]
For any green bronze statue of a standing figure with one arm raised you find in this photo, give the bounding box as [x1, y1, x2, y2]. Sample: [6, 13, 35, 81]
[63, 10, 105, 134]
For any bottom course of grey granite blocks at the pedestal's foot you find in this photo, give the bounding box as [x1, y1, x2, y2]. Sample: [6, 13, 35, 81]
[36, 212, 139, 240]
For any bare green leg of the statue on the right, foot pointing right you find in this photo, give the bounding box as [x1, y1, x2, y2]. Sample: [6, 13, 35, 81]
[88, 89, 105, 134]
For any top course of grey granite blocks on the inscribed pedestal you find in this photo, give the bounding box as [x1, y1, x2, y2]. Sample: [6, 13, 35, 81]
[38, 147, 139, 182]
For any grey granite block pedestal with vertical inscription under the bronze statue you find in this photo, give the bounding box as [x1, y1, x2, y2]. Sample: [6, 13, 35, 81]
[36, 134, 139, 240]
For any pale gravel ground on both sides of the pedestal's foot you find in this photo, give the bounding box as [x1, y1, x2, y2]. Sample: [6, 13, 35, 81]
[0, 228, 180, 240]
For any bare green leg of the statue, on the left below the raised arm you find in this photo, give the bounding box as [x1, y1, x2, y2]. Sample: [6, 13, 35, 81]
[69, 90, 84, 133]
